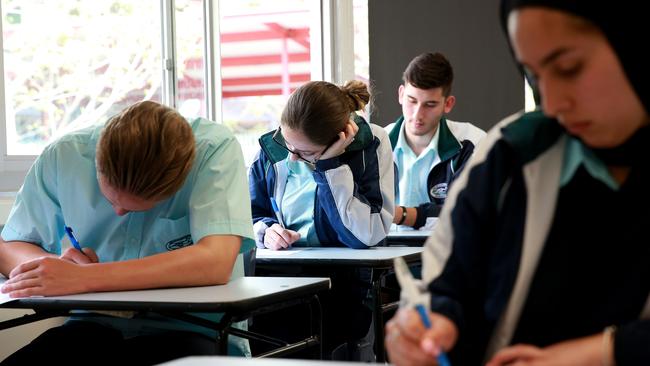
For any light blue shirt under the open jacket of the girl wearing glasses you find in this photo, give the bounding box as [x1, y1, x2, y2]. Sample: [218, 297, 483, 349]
[280, 159, 320, 246]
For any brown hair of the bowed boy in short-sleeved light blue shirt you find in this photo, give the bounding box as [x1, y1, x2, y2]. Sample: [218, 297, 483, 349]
[97, 101, 196, 201]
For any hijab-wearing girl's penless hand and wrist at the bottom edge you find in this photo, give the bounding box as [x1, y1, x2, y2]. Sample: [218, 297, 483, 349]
[486, 333, 614, 366]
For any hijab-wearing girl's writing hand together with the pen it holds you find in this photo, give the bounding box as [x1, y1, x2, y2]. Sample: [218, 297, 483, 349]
[385, 258, 458, 366]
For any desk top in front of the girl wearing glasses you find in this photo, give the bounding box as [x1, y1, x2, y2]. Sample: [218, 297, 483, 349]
[256, 247, 423, 267]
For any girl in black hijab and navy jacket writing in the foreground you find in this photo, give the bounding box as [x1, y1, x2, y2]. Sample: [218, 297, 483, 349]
[386, 0, 650, 366]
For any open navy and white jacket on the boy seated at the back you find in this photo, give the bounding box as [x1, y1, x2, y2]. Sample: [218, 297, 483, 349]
[385, 116, 485, 228]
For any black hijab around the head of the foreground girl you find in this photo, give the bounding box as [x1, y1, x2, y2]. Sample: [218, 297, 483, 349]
[500, 0, 650, 166]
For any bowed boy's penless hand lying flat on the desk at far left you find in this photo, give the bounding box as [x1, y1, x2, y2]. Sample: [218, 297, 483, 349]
[2, 257, 92, 297]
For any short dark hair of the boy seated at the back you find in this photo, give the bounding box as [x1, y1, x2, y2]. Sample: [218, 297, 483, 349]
[402, 52, 454, 97]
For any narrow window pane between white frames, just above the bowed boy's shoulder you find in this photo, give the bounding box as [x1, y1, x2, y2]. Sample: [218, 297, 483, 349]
[175, 0, 207, 118]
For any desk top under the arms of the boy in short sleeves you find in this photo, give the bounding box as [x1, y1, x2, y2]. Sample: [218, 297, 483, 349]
[0, 277, 330, 314]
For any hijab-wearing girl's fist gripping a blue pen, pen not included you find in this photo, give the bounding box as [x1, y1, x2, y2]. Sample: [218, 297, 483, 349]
[384, 309, 458, 366]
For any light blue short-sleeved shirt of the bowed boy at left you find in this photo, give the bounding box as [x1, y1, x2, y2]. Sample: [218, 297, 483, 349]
[2, 118, 254, 354]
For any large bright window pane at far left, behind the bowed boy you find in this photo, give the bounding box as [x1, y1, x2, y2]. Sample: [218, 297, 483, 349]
[2, 0, 162, 155]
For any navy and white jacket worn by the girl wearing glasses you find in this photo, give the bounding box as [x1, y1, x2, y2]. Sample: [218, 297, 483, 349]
[249, 115, 395, 249]
